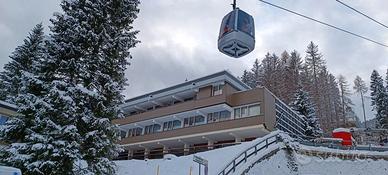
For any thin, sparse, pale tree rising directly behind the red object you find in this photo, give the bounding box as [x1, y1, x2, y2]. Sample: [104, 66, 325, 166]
[338, 75, 354, 127]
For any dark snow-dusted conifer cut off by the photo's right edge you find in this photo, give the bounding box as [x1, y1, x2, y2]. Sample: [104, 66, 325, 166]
[370, 70, 388, 129]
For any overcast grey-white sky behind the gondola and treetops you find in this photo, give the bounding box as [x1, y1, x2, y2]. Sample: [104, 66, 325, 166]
[0, 0, 388, 121]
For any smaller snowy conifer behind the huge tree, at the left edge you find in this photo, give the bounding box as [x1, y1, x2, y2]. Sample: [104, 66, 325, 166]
[0, 24, 44, 103]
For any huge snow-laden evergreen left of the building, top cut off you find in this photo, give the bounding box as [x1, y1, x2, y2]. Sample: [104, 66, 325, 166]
[1, 0, 139, 175]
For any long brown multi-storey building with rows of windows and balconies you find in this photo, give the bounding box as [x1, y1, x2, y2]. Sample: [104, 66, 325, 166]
[114, 71, 305, 159]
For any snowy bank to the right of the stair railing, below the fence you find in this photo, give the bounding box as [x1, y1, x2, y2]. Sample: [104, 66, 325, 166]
[248, 150, 388, 175]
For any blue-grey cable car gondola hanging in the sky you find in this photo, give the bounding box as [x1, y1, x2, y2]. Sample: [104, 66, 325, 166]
[218, 0, 255, 58]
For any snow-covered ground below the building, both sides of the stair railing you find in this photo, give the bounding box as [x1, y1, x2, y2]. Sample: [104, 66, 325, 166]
[116, 132, 388, 175]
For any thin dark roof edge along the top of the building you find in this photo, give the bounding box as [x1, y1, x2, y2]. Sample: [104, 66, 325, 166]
[125, 70, 250, 103]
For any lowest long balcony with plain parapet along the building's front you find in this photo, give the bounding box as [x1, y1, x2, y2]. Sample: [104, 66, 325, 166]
[119, 115, 268, 148]
